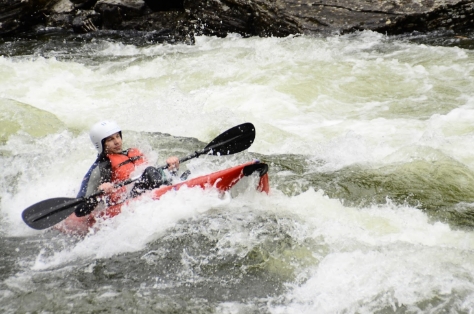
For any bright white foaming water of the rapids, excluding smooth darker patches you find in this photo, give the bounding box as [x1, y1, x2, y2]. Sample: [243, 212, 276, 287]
[0, 32, 474, 313]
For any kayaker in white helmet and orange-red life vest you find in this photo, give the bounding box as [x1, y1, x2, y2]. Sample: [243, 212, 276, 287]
[76, 121, 179, 217]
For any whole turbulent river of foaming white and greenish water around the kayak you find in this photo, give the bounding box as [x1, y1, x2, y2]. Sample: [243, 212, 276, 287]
[0, 32, 474, 314]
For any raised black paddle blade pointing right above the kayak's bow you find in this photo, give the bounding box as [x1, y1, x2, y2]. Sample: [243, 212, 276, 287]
[204, 122, 255, 155]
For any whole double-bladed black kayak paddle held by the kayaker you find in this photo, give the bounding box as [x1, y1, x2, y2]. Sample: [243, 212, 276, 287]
[22, 122, 255, 230]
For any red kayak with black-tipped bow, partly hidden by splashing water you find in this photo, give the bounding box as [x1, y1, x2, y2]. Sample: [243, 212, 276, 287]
[54, 161, 270, 235]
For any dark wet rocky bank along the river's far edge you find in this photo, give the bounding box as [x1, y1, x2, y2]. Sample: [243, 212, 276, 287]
[0, 0, 474, 40]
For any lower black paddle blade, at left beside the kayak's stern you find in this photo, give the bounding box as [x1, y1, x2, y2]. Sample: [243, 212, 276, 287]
[22, 197, 84, 230]
